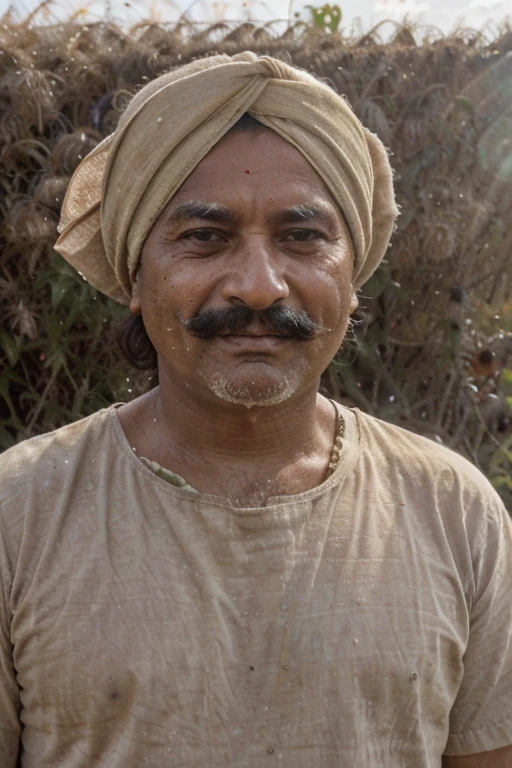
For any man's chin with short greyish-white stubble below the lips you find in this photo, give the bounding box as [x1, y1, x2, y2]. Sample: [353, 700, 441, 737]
[207, 373, 299, 408]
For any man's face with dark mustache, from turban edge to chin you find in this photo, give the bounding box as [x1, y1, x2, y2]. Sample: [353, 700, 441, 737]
[130, 130, 357, 407]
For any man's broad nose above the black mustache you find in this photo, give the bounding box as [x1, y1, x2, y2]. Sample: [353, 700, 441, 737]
[222, 236, 290, 311]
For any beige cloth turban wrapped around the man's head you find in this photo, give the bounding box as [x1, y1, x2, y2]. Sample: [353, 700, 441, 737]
[55, 52, 397, 304]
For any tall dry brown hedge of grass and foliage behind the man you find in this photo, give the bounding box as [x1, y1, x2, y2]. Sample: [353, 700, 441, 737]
[0, 10, 512, 510]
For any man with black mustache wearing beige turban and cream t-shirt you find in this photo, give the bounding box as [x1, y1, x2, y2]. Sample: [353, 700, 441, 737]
[0, 53, 512, 768]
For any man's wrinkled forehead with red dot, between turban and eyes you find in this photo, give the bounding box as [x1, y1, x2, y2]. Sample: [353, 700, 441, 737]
[147, 126, 352, 247]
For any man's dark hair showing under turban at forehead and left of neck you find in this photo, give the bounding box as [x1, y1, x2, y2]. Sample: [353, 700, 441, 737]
[116, 112, 271, 372]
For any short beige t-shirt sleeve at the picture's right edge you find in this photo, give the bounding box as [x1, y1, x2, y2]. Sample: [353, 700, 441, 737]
[445, 489, 512, 756]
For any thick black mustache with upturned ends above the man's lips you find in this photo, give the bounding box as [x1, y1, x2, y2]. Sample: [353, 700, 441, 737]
[180, 306, 325, 341]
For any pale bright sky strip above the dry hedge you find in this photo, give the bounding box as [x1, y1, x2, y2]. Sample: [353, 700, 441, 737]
[0, 0, 512, 34]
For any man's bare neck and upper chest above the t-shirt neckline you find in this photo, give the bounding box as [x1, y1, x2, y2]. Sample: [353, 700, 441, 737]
[119, 372, 335, 506]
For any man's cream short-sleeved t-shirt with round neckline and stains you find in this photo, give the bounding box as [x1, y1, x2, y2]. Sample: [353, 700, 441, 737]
[0, 408, 512, 768]
